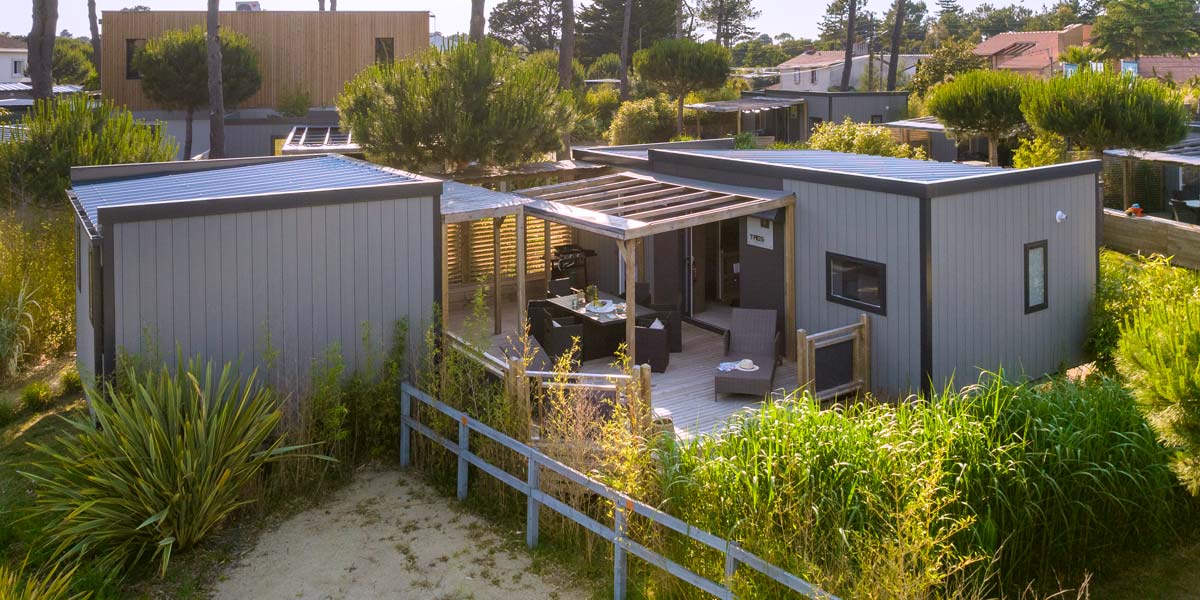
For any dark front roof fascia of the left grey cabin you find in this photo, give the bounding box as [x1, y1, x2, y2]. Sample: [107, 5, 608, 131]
[96, 179, 442, 229]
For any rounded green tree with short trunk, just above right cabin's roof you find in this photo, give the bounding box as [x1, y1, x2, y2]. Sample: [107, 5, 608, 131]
[926, 70, 1028, 166]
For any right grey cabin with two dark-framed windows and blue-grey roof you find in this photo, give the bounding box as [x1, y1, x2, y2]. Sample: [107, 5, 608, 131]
[576, 144, 1100, 394]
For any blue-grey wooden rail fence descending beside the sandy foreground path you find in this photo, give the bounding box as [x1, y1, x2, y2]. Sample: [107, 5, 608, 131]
[400, 383, 838, 600]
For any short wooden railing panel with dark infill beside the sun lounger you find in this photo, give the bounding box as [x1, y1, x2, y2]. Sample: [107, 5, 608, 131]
[796, 314, 871, 400]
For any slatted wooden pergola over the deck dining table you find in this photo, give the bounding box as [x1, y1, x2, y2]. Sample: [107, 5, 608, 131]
[516, 172, 796, 356]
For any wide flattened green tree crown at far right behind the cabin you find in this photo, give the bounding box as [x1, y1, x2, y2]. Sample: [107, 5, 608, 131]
[1021, 71, 1190, 154]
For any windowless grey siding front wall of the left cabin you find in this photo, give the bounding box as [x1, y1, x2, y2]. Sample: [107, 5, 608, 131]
[106, 197, 440, 389]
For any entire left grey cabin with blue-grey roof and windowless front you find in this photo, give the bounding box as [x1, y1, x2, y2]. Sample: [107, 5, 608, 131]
[71, 155, 442, 386]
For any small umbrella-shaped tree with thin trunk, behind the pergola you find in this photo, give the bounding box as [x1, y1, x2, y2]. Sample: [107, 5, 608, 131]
[634, 40, 730, 134]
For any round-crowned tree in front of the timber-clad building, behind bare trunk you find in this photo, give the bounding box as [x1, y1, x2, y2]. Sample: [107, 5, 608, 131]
[133, 25, 263, 156]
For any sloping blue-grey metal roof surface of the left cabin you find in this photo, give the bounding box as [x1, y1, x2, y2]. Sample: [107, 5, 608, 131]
[71, 155, 431, 232]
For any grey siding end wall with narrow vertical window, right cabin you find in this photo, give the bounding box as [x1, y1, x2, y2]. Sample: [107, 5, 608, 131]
[931, 175, 1096, 386]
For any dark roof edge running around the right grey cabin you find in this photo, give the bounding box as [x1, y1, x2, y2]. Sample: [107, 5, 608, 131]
[648, 149, 1102, 198]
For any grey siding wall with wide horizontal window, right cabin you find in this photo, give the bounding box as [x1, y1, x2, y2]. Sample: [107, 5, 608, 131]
[780, 180, 920, 394]
